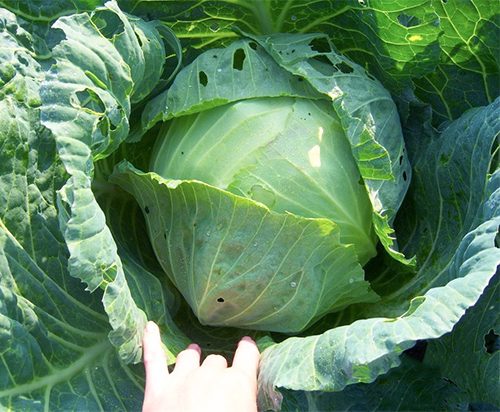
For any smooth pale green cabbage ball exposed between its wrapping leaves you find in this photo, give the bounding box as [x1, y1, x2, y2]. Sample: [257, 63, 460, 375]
[151, 97, 376, 265]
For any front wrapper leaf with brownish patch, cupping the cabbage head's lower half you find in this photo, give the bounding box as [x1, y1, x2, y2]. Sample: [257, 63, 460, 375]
[111, 163, 378, 332]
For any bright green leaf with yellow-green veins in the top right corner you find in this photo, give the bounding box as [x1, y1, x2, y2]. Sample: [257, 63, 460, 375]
[414, 0, 500, 124]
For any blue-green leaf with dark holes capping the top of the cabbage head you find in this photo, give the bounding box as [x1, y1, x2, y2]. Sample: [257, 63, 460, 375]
[142, 36, 322, 132]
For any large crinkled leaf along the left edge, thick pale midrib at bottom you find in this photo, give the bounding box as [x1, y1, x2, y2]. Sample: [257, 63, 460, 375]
[0, 10, 150, 411]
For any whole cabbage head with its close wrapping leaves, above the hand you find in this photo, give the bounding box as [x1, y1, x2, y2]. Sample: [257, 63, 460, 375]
[113, 35, 410, 333]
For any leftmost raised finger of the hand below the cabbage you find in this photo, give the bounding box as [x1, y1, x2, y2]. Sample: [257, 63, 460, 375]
[142, 322, 168, 386]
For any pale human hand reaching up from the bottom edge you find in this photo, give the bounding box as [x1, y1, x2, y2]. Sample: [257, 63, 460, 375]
[142, 322, 260, 412]
